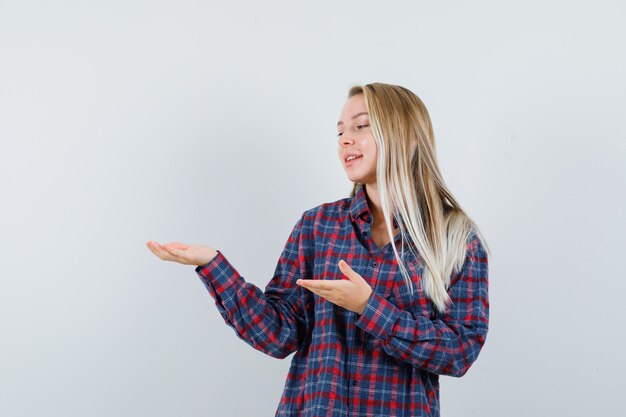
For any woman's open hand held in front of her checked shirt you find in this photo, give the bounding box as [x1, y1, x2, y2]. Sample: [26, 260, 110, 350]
[296, 259, 373, 314]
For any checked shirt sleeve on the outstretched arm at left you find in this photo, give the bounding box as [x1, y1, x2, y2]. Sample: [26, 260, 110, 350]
[196, 213, 307, 359]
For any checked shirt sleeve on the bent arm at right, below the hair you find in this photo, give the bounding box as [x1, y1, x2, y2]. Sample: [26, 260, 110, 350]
[355, 233, 489, 377]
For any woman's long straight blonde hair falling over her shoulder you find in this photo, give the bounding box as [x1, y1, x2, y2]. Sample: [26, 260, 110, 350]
[348, 83, 489, 313]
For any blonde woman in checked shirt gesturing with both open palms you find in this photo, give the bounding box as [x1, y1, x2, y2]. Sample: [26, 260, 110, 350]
[148, 83, 489, 416]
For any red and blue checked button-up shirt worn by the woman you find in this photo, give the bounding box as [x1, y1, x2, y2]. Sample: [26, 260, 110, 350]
[196, 186, 489, 417]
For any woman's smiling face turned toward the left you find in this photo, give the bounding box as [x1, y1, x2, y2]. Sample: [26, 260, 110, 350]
[337, 94, 378, 184]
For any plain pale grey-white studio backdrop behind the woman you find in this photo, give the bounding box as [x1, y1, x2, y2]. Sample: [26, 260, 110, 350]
[0, 0, 626, 417]
